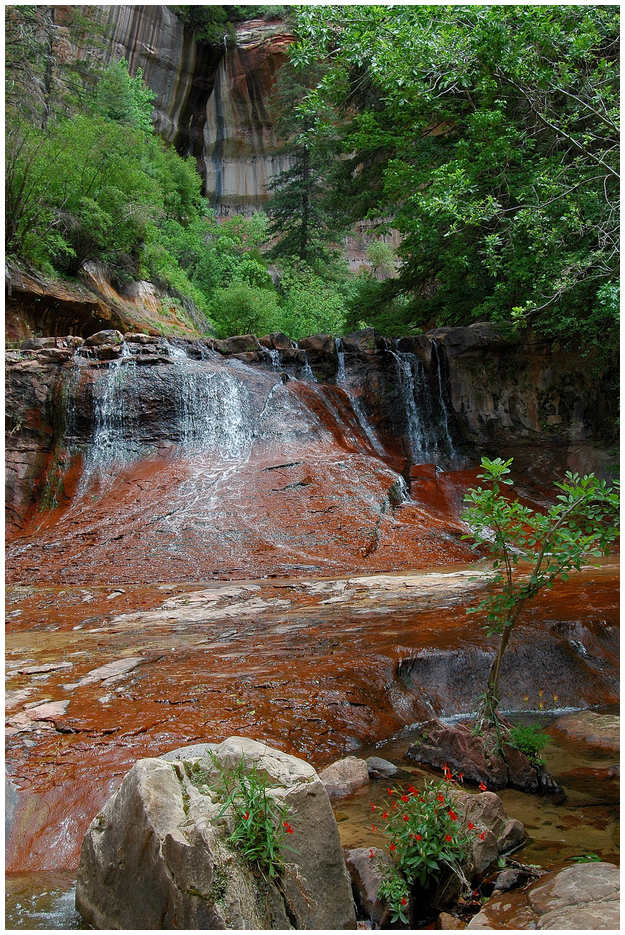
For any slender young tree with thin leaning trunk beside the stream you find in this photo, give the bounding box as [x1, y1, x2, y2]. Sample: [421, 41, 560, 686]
[463, 458, 619, 726]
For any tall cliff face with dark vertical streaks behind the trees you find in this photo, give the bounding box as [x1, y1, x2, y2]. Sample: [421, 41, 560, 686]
[89, 6, 293, 217]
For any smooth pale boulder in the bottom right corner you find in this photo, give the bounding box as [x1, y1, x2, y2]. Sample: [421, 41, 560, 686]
[467, 862, 619, 930]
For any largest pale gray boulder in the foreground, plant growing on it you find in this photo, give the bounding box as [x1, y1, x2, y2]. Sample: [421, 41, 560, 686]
[76, 737, 356, 929]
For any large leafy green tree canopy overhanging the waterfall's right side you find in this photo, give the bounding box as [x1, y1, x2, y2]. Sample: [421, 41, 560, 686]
[292, 5, 619, 346]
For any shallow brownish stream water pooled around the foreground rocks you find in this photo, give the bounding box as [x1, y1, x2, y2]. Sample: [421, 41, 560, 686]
[6, 706, 619, 929]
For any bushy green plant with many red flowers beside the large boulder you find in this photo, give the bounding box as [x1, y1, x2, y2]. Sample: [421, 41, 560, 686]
[374, 779, 472, 922]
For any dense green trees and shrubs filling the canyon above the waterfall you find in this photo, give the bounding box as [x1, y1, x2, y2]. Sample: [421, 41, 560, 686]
[6, 6, 619, 349]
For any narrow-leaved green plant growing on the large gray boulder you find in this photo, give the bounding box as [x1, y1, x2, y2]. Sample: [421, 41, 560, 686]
[211, 753, 295, 877]
